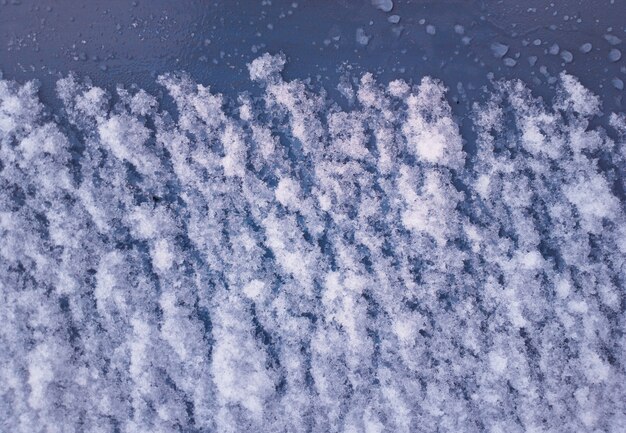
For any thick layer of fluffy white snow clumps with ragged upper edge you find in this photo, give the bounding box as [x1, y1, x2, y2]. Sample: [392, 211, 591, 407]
[0, 54, 626, 433]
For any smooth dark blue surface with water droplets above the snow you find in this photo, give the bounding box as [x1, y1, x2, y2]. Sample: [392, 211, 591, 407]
[0, 0, 626, 114]
